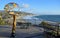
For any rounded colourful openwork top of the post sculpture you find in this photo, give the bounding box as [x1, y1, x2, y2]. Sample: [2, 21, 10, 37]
[4, 2, 19, 11]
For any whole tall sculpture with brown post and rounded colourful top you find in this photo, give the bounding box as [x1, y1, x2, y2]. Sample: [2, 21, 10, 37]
[4, 2, 19, 37]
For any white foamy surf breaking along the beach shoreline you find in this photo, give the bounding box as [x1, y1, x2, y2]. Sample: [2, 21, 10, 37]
[23, 16, 42, 24]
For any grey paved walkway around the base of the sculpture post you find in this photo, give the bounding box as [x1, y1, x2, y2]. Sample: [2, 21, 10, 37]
[0, 25, 44, 38]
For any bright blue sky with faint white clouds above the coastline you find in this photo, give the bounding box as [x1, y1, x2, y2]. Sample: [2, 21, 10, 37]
[0, 0, 60, 15]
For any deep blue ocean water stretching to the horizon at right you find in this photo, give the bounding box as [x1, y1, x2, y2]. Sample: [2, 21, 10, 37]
[35, 15, 60, 22]
